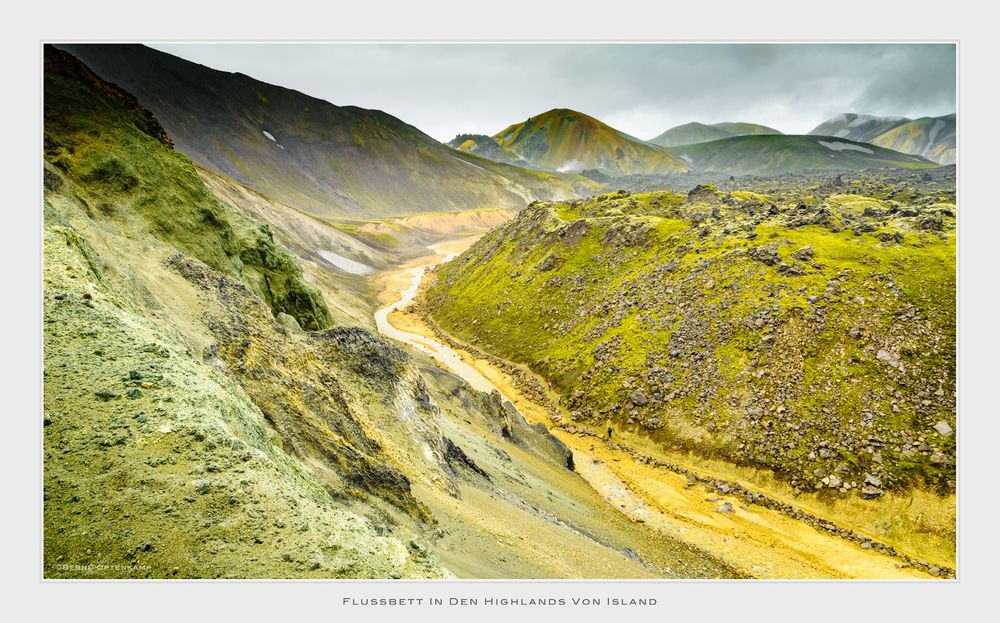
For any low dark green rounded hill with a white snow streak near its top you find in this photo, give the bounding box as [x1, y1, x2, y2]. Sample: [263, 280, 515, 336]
[672, 135, 938, 175]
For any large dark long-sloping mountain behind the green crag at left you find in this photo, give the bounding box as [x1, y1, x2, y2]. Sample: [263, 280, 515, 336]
[61, 44, 579, 217]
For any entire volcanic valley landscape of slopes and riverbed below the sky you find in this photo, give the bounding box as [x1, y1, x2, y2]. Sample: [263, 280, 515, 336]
[41, 44, 959, 579]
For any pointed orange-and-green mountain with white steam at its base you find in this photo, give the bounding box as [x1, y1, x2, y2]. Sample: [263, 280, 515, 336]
[459, 108, 688, 177]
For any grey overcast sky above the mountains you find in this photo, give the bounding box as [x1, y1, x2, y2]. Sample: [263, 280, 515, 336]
[152, 43, 955, 141]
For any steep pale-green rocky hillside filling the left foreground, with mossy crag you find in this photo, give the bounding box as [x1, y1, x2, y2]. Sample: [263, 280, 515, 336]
[44, 47, 458, 577]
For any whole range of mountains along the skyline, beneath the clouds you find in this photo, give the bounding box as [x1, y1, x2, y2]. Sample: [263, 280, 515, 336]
[56, 44, 955, 219]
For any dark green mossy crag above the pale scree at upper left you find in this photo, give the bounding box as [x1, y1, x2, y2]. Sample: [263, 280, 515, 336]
[45, 44, 330, 329]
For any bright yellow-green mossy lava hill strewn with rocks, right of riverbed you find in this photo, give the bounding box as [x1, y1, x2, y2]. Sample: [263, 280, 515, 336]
[426, 172, 955, 498]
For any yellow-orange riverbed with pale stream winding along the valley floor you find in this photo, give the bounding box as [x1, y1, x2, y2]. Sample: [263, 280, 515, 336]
[376, 239, 931, 579]
